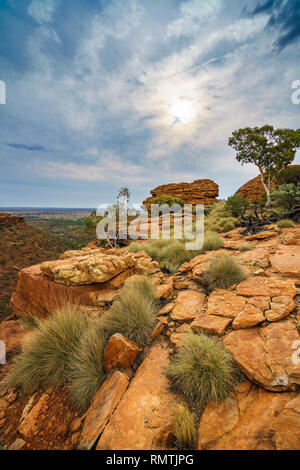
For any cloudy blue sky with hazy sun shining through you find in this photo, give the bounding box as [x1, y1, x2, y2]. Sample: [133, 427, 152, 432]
[0, 0, 300, 207]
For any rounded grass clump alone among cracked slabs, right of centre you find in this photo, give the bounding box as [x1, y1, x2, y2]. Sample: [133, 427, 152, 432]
[204, 254, 247, 290]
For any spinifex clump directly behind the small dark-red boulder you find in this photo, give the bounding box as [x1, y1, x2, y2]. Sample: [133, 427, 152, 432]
[101, 276, 156, 346]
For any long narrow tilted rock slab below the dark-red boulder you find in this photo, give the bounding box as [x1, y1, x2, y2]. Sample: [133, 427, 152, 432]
[79, 371, 129, 450]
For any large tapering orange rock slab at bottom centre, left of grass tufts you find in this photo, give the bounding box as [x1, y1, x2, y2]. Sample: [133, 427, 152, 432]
[97, 342, 176, 451]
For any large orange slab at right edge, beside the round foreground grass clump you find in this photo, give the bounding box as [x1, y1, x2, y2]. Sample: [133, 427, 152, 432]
[224, 320, 300, 391]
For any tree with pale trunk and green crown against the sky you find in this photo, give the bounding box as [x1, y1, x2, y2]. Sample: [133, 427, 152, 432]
[228, 125, 300, 206]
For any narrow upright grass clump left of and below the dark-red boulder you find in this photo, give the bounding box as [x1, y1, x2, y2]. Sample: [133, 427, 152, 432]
[68, 322, 105, 410]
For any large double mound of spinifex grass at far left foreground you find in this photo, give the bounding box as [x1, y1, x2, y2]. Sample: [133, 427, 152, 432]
[2, 305, 104, 408]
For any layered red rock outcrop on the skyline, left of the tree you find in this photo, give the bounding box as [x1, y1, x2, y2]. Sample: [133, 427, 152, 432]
[143, 179, 219, 209]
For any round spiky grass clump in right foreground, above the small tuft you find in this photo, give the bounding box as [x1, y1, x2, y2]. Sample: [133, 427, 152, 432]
[167, 333, 237, 407]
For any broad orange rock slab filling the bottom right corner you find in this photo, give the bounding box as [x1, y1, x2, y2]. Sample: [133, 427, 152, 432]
[197, 381, 300, 450]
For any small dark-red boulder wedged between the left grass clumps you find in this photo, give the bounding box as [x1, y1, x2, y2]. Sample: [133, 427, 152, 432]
[104, 333, 139, 372]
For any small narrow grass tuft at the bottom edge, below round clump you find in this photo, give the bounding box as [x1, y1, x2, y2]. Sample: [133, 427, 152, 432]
[173, 405, 197, 450]
